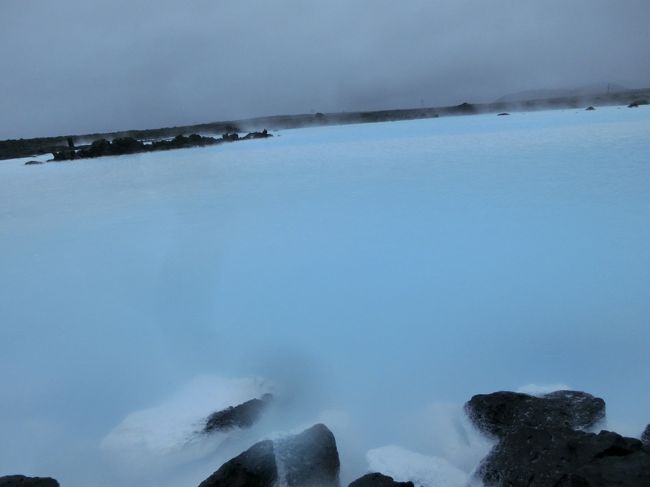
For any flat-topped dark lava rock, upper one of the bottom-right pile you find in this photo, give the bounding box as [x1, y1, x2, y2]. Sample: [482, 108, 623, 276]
[465, 391, 605, 438]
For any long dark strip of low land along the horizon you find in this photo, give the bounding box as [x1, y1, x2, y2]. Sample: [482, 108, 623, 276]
[0, 88, 650, 160]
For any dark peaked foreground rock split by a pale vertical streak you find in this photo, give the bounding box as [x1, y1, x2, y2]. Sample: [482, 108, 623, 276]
[199, 424, 340, 487]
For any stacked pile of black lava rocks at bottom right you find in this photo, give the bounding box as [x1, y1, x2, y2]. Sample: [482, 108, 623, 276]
[465, 391, 650, 487]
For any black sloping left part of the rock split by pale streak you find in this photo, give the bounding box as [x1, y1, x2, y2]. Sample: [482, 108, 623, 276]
[199, 440, 278, 487]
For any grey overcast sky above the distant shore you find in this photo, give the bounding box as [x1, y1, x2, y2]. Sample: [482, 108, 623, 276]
[0, 0, 650, 139]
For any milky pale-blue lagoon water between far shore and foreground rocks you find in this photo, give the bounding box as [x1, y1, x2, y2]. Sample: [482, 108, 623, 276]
[0, 107, 650, 487]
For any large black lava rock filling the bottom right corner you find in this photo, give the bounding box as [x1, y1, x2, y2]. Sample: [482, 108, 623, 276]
[478, 427, 650, 487]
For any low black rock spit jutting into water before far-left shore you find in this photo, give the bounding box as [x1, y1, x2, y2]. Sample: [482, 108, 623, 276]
[52, 129, 272, 161]
